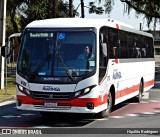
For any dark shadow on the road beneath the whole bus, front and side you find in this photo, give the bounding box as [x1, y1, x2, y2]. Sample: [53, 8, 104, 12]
[10, 99, 141, 128]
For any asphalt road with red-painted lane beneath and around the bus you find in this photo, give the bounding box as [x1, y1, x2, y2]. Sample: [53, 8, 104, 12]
[0, 75, 160, 137]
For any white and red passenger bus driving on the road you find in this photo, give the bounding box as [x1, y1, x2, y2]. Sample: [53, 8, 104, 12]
[16, 18, 155, 117]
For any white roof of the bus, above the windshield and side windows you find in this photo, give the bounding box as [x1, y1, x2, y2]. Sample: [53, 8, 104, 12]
[26, 18, 152, 37]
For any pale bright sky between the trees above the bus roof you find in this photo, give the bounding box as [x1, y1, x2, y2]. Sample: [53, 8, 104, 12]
[73, 0, 160, 30]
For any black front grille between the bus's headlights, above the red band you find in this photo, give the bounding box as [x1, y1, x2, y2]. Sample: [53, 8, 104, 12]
[30, 91, 73, 100]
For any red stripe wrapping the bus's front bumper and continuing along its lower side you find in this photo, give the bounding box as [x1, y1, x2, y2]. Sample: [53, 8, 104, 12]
[17, 80, 154, 107]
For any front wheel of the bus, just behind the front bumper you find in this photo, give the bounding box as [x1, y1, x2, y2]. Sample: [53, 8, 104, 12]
[99, 92, 112, 118]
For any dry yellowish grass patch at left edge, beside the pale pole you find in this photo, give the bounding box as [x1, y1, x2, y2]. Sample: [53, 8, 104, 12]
[0, 77, 16, 101]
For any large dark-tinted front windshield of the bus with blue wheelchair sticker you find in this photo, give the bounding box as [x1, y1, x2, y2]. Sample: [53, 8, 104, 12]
[17, 29, 96, 80]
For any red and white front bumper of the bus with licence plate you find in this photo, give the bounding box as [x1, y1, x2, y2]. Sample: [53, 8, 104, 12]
[17, 95, 108, 113]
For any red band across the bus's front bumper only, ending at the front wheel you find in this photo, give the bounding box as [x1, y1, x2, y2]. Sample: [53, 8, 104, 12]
[17, 94, 108, 107]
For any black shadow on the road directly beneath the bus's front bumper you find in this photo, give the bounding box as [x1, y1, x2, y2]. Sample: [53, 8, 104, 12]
[32, 113, 95, 127]
